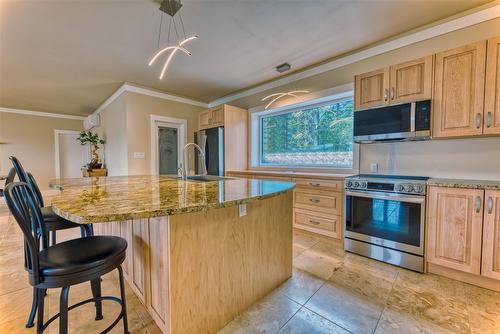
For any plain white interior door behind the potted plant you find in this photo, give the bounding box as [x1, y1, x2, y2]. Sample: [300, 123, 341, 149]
[55, 130, 90, 178]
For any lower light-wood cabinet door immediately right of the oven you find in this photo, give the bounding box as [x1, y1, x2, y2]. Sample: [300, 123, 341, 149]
[427, 187, 484, 274]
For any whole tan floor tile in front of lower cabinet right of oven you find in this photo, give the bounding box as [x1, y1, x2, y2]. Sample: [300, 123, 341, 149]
[387, 272, 469, 333]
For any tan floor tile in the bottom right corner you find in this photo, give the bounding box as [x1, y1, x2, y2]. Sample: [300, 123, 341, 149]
[465, 284, 500, 334]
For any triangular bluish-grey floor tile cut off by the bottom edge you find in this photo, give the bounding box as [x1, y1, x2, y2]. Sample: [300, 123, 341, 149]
[279, 307, 349, 334]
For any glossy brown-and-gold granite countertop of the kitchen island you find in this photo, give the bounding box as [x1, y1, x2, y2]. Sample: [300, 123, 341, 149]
[50, 175, 295, 224]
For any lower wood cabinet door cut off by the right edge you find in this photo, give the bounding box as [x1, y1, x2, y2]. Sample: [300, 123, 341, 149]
[481, 190, 500, 279]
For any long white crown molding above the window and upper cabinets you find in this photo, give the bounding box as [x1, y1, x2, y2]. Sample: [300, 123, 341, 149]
[208, 4, 500, 108]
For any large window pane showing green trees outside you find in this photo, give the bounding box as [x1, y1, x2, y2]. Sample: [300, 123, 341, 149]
[260, 100, 354, 168]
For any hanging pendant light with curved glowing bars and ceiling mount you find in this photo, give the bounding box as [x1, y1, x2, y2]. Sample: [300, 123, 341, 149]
[148, 0, 198, 80]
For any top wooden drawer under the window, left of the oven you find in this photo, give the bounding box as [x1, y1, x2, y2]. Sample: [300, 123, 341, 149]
[294, 190, 342, 215]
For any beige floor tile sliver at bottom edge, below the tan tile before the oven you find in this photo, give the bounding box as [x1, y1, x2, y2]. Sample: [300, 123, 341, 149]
[375, 309, 454, 334]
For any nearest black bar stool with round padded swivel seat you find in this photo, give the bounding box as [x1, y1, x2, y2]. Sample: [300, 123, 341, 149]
[4, 182, 128, 334]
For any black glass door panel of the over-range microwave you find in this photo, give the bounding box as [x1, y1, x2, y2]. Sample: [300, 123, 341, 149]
[354, 103, 411, 136]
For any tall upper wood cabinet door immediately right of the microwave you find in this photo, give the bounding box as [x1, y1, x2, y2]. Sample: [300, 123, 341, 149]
[433, 41, 486, 138]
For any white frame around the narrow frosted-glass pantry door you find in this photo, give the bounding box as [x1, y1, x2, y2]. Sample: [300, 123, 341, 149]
[149, 115, 187, 175]
